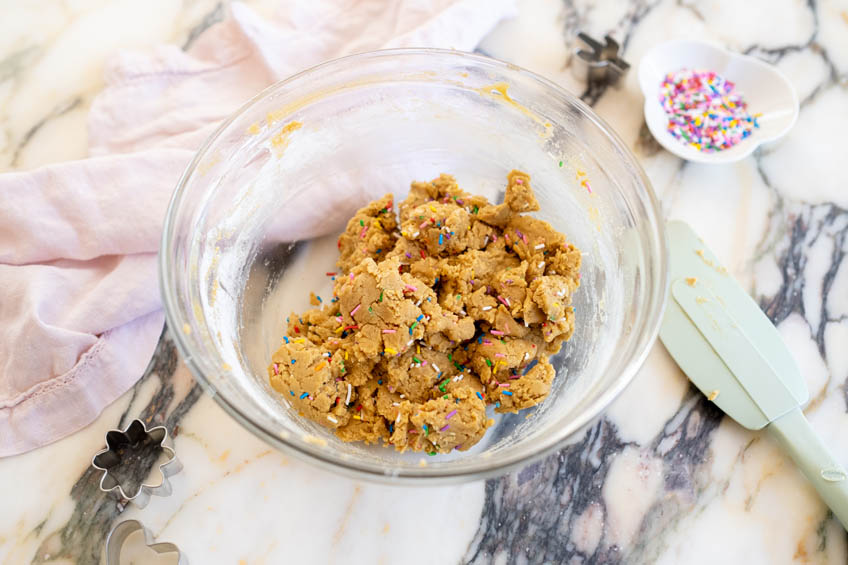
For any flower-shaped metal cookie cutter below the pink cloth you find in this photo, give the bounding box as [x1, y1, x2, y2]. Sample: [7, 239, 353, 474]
[91, 420, 183, 508]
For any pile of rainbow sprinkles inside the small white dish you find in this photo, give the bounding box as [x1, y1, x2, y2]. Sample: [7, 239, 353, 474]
[659, 69, 761, 153]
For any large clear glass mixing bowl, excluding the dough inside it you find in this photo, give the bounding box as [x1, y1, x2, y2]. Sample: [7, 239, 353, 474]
[160, 49, 667, 483]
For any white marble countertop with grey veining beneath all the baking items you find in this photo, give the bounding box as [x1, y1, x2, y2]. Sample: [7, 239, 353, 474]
[0, 0, 848, 565]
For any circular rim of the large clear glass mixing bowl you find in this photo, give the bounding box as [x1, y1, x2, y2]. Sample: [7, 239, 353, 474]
[158, 48, 668, 485]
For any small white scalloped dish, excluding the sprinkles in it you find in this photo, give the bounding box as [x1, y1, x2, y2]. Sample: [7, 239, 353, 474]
[639, 39, 798, 164]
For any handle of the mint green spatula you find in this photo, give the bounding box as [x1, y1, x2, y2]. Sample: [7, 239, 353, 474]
[768, 408, 848, 529]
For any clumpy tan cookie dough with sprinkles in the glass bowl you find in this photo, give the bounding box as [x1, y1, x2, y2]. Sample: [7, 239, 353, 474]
[268, 171, 580, 454]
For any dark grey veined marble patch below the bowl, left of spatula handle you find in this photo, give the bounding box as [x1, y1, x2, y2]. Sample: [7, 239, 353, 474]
[464, 391, 722, 564]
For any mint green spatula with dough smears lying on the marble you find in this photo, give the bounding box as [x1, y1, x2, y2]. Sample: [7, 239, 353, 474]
[660, 222, 848, 527]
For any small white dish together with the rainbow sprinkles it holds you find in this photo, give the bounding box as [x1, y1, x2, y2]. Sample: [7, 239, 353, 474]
[639, 40, 798, 163]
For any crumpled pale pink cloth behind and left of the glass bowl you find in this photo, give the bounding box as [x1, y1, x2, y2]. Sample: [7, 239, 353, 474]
[0, 0, 514, 456]
